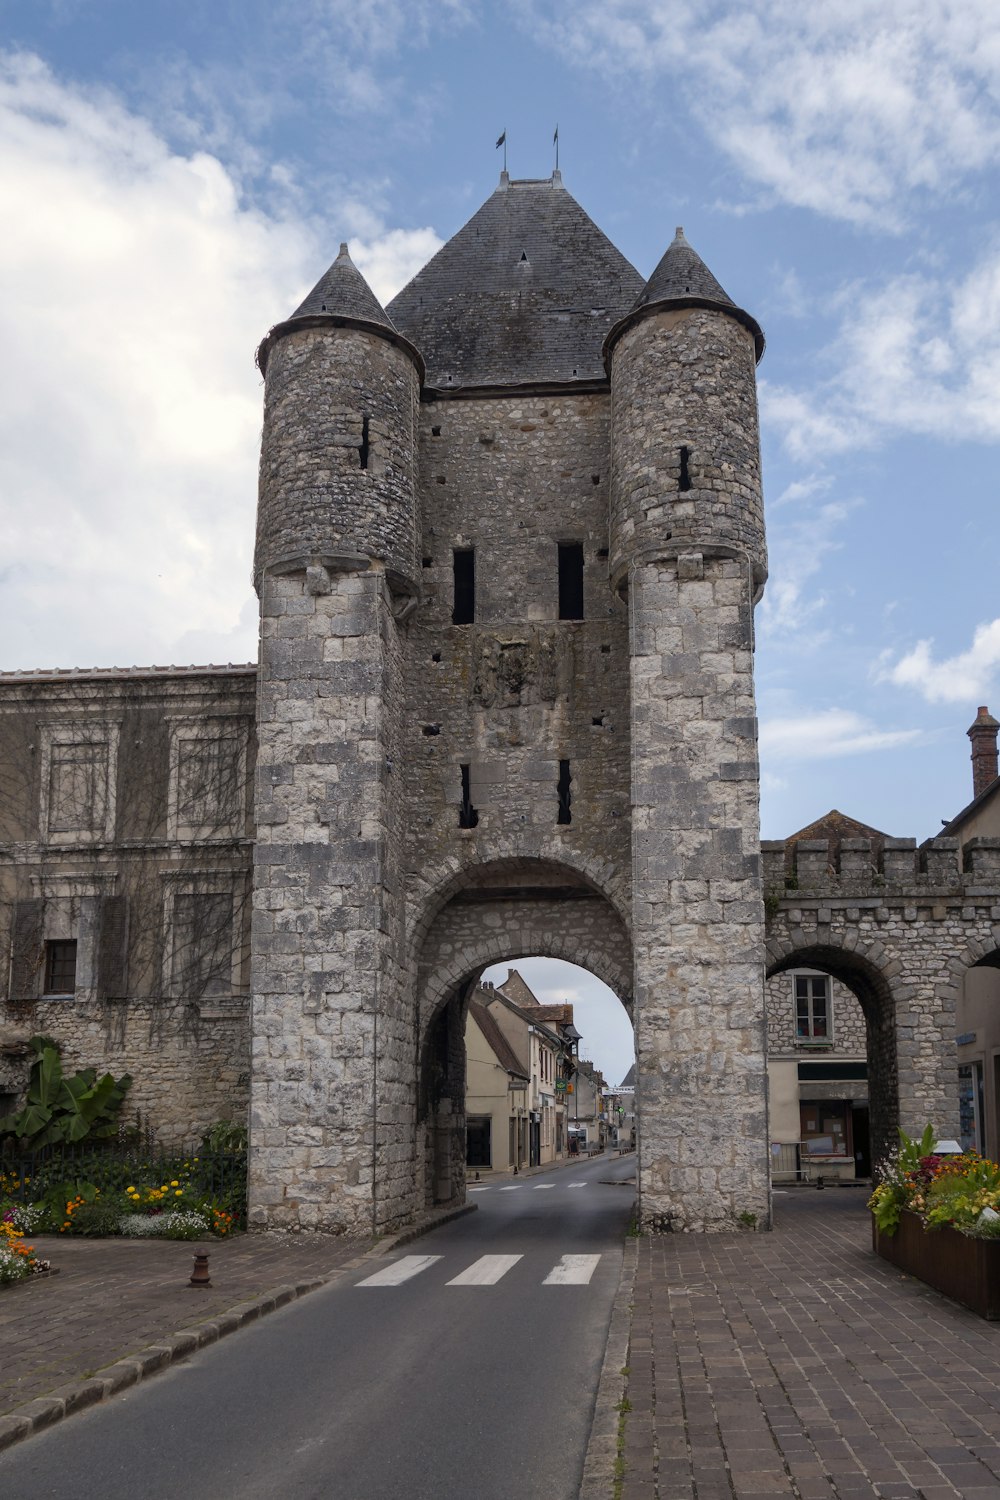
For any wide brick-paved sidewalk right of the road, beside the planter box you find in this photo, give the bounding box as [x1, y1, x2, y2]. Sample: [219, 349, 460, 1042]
[621, 1188, 1000, 1500]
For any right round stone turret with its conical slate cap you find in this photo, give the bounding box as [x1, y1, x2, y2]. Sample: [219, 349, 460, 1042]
[604, 230, 768, 594]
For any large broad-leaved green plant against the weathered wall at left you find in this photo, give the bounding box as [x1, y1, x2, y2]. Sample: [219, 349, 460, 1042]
[0, 1037, 132, 1151]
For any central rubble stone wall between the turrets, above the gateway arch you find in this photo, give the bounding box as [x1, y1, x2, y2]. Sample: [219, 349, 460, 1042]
[402, 395, 630, 929]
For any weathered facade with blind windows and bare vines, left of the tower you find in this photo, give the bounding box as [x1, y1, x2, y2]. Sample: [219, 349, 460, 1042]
[0, 668, 255, 1146]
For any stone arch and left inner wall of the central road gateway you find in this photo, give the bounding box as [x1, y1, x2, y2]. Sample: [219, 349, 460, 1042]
[417, 860, 633, 1206]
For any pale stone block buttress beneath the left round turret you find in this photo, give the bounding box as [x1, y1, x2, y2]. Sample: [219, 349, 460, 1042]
[250, 566, 394, 1233]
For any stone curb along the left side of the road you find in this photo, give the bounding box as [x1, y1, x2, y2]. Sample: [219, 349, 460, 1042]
[0, 1203, 478, 1452]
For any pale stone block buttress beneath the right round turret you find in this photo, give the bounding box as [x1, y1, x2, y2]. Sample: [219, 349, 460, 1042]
[628, 560, 769, 1230]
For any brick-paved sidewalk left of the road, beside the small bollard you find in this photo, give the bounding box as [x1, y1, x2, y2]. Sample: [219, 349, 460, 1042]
[0, 1235, 373, 1416]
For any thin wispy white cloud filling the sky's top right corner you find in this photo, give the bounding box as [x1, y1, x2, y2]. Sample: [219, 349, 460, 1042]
[519, 0, 1000, 228]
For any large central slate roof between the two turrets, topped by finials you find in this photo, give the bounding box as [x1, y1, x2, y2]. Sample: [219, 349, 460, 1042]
[388, 173, 643, 390]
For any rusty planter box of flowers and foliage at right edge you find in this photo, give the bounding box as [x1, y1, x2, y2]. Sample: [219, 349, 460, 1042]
[868, 1125, 1000, 1320]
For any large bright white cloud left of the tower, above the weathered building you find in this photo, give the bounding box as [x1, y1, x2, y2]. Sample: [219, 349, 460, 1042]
[0, 54, 439, 668]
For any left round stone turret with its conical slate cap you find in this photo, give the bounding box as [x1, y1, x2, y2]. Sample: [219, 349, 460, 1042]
[253, 245, 423, 596]
